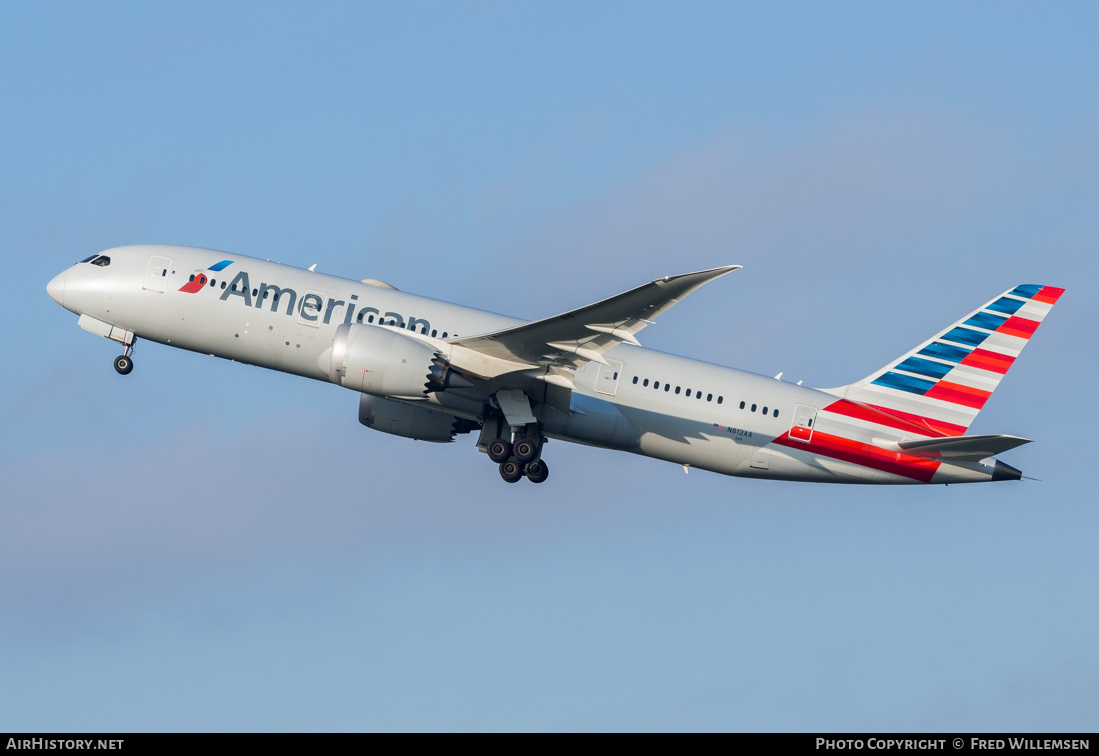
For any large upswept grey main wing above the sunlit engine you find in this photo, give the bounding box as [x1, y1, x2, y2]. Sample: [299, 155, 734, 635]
[448, 265, 741, 385]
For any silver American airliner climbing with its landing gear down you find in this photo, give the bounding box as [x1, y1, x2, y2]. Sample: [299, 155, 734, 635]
[46, 245, 1064, 483]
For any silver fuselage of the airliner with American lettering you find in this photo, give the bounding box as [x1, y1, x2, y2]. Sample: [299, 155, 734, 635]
[48, 245, 1028, 483]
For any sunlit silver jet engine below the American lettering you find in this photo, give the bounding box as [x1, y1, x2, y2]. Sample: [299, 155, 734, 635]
[329, 323, 473, 397]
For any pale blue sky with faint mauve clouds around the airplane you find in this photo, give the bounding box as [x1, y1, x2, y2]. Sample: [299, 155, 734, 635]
[0, 2, 1099, 732]
